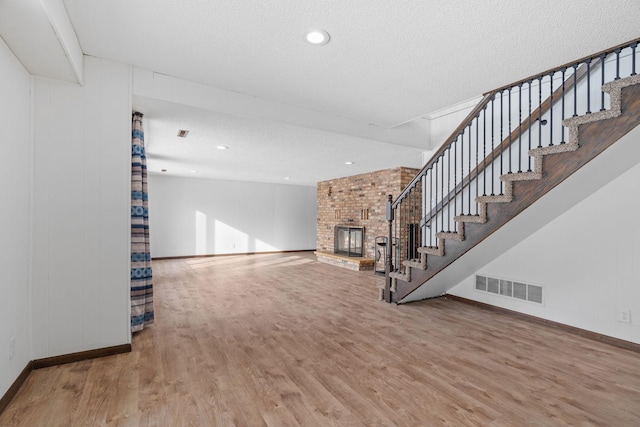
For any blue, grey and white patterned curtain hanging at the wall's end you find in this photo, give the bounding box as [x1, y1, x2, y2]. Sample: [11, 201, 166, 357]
[131, 112, 154, 332]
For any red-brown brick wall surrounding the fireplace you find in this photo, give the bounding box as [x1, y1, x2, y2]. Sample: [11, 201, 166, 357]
[316, 167, 418, 258]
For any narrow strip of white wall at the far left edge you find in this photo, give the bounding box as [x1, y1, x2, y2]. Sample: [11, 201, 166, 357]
[0, 39, 33, 396]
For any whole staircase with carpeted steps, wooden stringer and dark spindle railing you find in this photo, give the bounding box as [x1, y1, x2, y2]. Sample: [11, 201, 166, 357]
[380, 40, 640, 302]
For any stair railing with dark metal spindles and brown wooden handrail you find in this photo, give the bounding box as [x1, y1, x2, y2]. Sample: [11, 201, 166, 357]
[384, 39, 640, 301]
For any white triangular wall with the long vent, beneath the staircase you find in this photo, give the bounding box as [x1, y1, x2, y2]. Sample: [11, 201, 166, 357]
[449, 160, 640, 343]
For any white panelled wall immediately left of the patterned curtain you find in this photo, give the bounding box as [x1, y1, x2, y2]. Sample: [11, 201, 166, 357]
[30, 57, 131, 359]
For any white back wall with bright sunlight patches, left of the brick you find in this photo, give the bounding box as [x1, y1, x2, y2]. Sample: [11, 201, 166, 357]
[149, 175, 317, 258]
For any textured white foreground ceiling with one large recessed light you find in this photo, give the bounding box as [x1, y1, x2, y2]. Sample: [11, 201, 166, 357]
[64, 0, 640, 127]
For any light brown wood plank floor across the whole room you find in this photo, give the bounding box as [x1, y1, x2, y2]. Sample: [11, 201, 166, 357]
[0, 252, 640, 427]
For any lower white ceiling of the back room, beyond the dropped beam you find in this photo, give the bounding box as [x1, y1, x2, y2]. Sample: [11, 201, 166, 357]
[135, 97, 422, 186]
